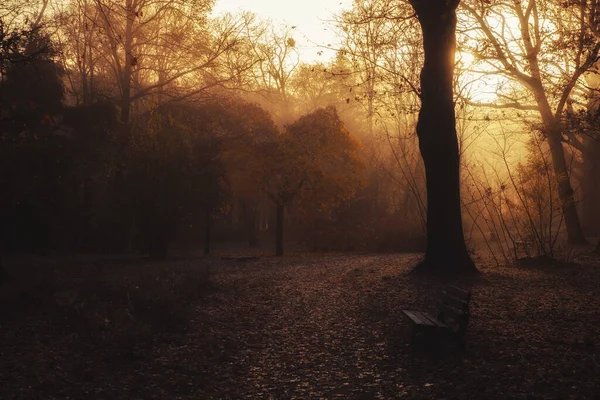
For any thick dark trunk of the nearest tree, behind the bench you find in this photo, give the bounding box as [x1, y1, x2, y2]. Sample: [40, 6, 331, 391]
[411, 0, 477, 275]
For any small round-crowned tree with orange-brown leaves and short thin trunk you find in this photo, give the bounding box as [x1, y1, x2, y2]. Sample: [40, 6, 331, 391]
[263, 107, 364, 256]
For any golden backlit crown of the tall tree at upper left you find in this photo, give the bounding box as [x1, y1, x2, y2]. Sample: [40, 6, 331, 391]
[57, 0, 242, 125]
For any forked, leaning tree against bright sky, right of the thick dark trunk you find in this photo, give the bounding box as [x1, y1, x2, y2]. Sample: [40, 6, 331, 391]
[464, 0, 600, 244]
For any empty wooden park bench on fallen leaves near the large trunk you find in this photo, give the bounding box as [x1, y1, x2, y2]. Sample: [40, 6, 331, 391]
[402, 286, 471, 349]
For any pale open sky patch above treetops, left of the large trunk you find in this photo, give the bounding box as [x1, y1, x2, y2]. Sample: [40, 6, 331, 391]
[213, 0, 352, 62]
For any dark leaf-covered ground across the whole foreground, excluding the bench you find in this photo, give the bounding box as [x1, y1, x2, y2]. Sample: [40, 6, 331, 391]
[0, 253, 600, 400]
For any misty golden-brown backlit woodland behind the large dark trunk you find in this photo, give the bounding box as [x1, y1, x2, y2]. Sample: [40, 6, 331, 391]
[0, 0, 600, 272]
